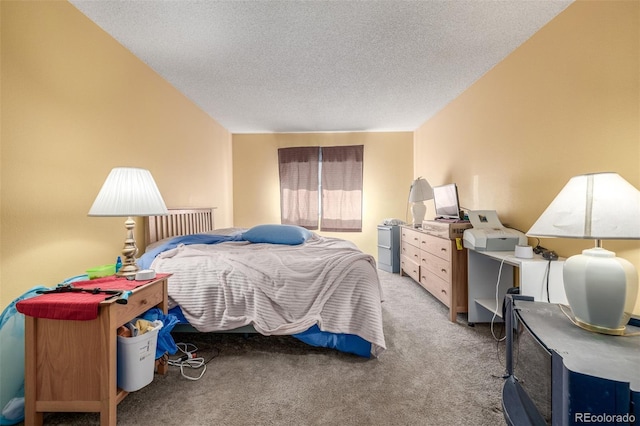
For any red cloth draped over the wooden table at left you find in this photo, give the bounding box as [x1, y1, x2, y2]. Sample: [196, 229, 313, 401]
[16, 274, 167, 321]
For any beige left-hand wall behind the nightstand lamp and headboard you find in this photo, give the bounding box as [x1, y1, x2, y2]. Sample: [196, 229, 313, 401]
[0, 1, 233, 306]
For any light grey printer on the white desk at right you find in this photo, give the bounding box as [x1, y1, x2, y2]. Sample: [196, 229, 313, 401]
[462, 210, 527, 251]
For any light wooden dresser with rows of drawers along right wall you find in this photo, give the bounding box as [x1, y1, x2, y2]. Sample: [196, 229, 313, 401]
[400, 221, 471, 322]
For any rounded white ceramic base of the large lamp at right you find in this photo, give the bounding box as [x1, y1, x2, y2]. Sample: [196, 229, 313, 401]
[563, 247, 638, 335]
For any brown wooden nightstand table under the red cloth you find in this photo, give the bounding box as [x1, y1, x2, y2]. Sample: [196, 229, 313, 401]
[25, 275, 169, 426]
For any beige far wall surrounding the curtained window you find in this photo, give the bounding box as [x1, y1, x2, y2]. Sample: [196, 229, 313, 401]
[233, 132, 413, 256]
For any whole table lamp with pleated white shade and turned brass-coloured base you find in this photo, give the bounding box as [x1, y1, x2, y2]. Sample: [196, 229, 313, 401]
[89, 167, 169, 278]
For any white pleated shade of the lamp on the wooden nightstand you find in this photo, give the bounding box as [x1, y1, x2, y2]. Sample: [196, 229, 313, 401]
[89, 167, 169, 217]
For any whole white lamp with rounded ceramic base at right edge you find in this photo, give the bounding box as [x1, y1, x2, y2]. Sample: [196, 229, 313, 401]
[527, 173, 640, 335]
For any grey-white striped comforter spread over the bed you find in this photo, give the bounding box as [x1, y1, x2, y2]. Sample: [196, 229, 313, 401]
[151, 234, 385, 356]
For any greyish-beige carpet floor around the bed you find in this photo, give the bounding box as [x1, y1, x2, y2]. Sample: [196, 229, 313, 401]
[31, 271, 504, 426]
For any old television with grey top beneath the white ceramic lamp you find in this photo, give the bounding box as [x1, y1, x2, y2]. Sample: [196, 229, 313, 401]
[502, 293, 640, 426]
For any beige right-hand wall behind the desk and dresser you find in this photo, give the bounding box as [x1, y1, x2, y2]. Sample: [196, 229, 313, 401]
[414, 1, 640, 312]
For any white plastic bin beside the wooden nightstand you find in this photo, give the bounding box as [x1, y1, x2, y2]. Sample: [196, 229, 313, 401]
[118, 321, 162, 392]
